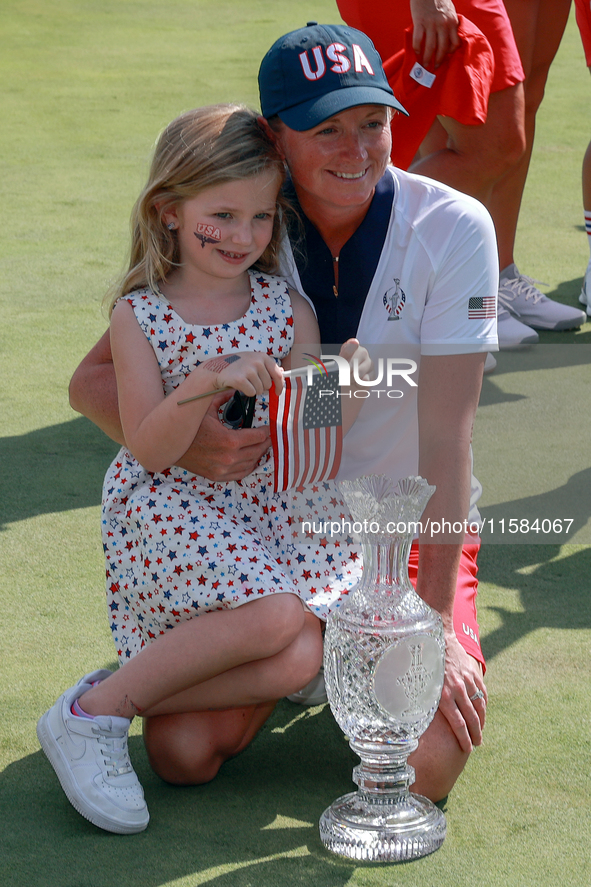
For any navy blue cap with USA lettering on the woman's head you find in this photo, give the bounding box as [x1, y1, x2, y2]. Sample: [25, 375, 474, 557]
[259, 22, 408, 132]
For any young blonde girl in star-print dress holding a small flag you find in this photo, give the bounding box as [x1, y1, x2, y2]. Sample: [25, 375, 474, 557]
[37, 105, 369, 834]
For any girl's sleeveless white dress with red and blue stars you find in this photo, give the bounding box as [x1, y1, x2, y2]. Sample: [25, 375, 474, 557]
[102, 272, 361, 662]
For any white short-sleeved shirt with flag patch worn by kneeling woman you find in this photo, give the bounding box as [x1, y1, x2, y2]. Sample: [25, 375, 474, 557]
[283, 167, 498, 520]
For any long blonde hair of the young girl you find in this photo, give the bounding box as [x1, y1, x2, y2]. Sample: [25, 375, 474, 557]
[105, 104, 287, 314]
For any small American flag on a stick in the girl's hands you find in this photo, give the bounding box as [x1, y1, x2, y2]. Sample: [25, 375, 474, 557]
[269, 372, 343, 493]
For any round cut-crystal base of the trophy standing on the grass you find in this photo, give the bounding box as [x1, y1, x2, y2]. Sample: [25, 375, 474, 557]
[320, 792, 446, 862]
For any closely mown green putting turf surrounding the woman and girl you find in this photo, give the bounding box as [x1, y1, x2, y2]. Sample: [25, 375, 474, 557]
[0, 0, 591, 887]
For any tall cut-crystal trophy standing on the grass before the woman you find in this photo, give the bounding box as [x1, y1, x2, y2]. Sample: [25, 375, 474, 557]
[320, 475, 446, 862]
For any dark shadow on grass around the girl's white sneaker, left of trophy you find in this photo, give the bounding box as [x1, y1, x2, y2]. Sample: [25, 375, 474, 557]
[0, 701, 366, 887]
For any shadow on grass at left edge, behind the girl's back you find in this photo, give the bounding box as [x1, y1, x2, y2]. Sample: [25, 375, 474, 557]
[0, 417, 119, 528]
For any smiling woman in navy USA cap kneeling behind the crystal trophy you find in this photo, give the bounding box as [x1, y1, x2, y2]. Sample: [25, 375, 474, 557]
[60, 23, 498, 824]
